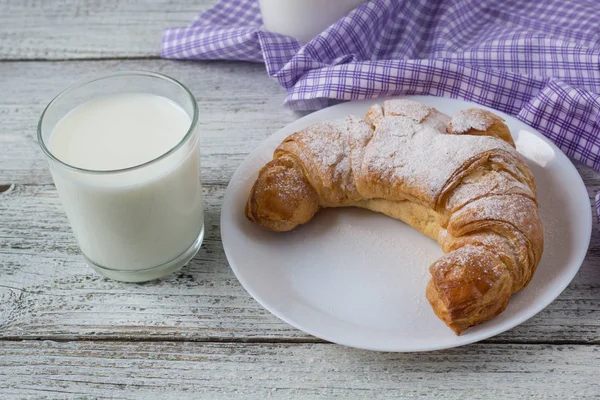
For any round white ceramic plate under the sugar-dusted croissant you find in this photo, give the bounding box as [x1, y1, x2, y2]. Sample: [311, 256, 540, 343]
[221, 96, 592, 351]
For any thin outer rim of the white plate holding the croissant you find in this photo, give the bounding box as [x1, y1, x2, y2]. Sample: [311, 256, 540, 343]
[219, 95, 593, 353]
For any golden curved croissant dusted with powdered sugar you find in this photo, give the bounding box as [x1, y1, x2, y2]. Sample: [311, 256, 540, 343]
[245, 100, 543, 335]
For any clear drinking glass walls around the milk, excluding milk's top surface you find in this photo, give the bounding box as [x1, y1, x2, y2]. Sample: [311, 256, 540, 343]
[38, 71, 204, 282]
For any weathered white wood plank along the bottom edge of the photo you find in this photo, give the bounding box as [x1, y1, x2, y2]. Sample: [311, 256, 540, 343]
[0, 341, 600, 400]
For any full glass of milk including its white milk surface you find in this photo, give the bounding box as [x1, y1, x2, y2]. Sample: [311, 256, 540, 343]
[38, 71, 204, 282]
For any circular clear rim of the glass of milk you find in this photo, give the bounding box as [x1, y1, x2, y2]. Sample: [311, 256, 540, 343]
[37, 70, 198, 175]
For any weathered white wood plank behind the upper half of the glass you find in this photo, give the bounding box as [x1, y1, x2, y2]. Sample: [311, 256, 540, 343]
[0, 60, 300, 184]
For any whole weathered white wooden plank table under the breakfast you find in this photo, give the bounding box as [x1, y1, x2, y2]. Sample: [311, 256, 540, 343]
[0, 0, 600, 399]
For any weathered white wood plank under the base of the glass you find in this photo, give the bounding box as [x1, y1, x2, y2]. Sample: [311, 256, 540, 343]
[0, 185, 600, 344]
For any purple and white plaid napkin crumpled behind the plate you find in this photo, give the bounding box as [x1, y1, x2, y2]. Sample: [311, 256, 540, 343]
[162, 0, 600, 219]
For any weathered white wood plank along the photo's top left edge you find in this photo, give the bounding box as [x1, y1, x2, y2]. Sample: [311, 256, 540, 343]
[0, 0, 216, 60]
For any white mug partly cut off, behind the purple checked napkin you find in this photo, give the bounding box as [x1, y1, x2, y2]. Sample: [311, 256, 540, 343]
[259, 0, 365, 43]
